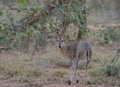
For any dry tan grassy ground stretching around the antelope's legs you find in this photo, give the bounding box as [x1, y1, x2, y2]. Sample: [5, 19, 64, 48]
[0, 25, 120, 87]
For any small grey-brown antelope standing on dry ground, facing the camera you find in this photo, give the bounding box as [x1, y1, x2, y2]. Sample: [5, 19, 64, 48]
[56, 34, 92, 85]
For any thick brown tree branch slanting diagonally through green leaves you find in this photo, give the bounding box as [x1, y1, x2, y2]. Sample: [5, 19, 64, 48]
[14, 0, 71, 31]
